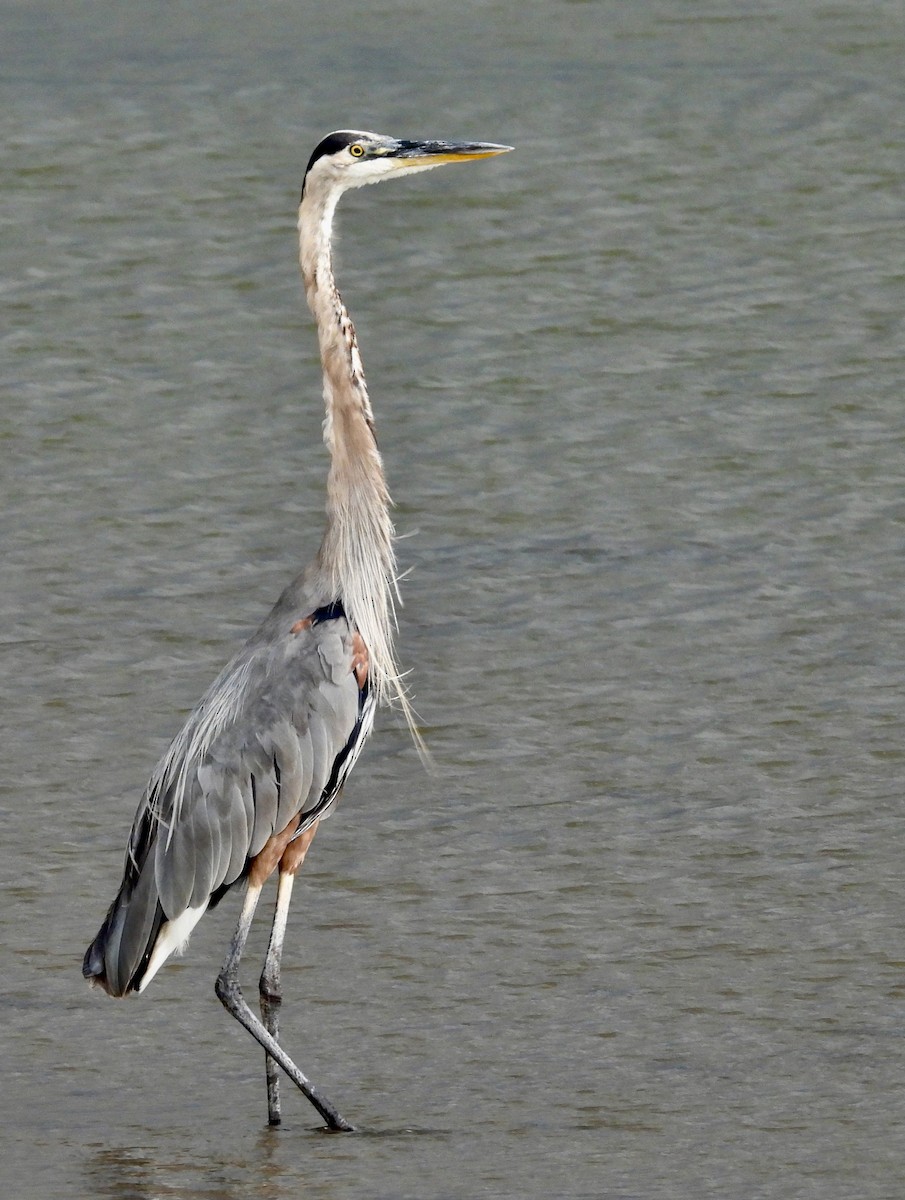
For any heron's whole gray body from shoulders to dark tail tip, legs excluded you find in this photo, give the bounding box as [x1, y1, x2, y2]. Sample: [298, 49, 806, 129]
[83, 583, 373, 995]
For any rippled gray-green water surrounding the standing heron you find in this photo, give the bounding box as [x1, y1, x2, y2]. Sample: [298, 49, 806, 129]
[0, 0, 905, 1200]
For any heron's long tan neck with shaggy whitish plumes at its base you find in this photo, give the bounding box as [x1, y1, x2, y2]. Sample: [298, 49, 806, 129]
[299, 191, 400, 710]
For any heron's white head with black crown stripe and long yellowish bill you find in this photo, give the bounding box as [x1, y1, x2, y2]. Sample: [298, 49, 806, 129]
[301, 130, 513, 197]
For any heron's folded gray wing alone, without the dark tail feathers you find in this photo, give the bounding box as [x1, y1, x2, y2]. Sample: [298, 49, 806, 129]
[148, 609, 360, 920]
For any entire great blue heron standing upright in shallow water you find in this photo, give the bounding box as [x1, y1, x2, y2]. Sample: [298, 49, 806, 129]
[82, 130, 511, 1129]
